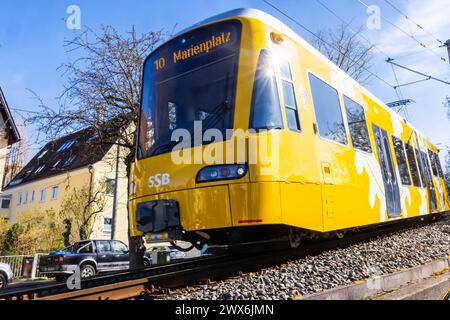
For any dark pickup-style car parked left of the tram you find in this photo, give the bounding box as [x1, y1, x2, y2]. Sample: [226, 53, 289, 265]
[39, 240, 130, 280]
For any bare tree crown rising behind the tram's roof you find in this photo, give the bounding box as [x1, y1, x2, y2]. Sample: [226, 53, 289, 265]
[310, 24, 375, 84]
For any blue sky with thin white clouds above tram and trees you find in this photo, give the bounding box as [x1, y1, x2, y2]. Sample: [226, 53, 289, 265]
[0, 0, 450, 160]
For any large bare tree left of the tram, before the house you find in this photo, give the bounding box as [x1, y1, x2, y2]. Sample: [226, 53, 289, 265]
[25, 26, 165, 268]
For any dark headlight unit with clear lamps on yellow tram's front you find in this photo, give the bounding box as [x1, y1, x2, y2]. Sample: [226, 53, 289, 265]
[197, 164, 248, 183]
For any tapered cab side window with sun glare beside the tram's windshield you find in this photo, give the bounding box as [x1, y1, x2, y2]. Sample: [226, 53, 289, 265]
[250, 50, 283, 130]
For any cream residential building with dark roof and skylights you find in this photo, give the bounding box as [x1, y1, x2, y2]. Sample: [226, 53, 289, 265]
[0, 128, 128, 243]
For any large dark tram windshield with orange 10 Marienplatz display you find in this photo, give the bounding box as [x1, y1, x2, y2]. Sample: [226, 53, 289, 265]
[138, 20, 242, 159]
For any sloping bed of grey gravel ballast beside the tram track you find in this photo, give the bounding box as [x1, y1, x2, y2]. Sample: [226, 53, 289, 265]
[168, 220, 450, 300]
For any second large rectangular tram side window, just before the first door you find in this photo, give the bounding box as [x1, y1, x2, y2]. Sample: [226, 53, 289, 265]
[344, 96, 372, 153]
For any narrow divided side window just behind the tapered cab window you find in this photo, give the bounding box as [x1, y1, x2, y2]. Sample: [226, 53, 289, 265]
[280, 60, 301, 131]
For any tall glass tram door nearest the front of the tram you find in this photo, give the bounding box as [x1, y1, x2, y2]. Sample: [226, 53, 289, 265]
[373, 125, 402, 218]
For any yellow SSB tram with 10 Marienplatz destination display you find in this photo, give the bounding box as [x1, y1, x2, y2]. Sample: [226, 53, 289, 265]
[130, 9, 449, 247]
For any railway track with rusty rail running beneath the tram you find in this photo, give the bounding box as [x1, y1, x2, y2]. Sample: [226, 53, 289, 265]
[0, 215, 448, 300]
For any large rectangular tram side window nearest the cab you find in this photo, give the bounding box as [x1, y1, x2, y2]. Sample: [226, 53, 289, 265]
[309, 73, 348, 145]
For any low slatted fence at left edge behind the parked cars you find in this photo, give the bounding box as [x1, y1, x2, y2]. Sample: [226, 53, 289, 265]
[0, 253, 45, 279]
